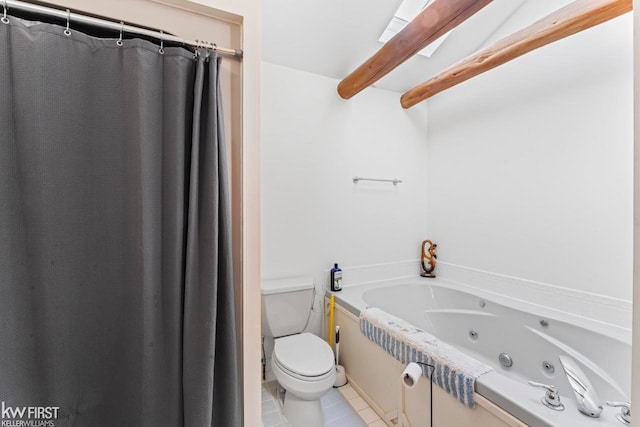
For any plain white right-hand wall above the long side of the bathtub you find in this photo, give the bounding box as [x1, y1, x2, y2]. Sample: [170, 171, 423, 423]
[426, 9, 633, 301]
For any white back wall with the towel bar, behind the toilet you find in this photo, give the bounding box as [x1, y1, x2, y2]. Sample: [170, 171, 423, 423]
[261, 62, 427, 290]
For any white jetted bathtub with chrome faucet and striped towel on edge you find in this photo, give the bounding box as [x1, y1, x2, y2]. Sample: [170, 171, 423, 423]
[335, 278, 631, 427]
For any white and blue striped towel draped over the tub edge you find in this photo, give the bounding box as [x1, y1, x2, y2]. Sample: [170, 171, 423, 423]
[360, 307, 493, 408]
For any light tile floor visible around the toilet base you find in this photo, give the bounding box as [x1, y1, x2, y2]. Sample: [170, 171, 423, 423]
[262, 381, 386, 427]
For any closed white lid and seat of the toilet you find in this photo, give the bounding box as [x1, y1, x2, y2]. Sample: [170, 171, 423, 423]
[273, 332, 335, 377]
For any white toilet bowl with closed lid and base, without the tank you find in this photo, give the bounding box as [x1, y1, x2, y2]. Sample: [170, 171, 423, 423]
[271, 333, 336, 427]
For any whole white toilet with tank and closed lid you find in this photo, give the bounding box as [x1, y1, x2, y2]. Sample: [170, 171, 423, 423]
[262, 277, 336, 427]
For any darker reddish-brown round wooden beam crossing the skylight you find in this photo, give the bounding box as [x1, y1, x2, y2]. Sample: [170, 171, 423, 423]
[338, 0, 492, 99]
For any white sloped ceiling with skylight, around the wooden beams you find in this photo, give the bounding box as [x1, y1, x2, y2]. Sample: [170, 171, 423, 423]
[262, 0, 569, 92]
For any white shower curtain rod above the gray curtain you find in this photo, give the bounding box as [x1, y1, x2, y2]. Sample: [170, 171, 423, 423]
[0, 0, 242, 59]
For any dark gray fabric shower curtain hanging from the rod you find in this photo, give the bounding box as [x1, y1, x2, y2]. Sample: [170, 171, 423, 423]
[0, 17, 241, 427]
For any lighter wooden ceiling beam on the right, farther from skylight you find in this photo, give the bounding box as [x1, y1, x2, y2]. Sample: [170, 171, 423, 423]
[400, 0, 633, 108]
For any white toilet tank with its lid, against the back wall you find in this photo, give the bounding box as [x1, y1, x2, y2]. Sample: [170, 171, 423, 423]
[262, 277, 313, 338]
